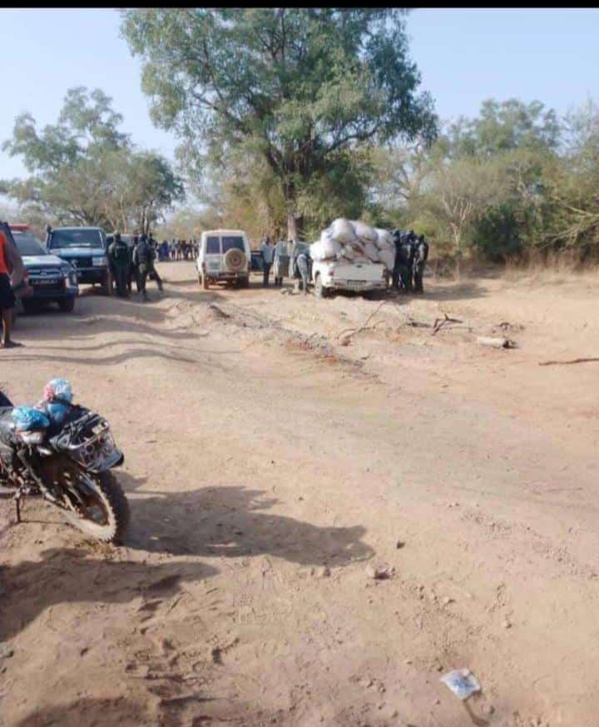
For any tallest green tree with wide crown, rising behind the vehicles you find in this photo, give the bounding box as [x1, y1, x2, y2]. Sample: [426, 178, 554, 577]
[122, 8, 436, 238]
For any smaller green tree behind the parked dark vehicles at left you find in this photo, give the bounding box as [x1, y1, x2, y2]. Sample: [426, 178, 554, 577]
[1, 87, 184, 231]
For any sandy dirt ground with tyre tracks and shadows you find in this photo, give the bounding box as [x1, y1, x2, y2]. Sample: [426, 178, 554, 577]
[0, 262, 599, 727]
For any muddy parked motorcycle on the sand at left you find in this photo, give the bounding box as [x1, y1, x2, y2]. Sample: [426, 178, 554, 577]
[0, 395, 129, 544]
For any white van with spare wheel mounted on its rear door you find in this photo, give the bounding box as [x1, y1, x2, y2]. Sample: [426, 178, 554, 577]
[196, 230, 252, 290]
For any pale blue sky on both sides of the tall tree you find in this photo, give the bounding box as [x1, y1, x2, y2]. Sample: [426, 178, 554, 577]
[0, 9, 599, 185]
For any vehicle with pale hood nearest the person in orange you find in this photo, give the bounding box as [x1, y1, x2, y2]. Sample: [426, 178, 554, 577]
[10, 225, 79, 312]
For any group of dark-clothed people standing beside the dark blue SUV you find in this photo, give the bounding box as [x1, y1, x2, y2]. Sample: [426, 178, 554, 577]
[108, 232, 162, 301]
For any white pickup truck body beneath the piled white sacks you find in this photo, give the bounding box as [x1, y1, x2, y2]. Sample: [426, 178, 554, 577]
[312, 260, 389, 298]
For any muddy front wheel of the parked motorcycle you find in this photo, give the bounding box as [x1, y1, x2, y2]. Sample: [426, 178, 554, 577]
[63, 472, 129, 545]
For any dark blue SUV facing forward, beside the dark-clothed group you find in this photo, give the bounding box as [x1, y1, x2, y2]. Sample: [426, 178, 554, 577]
[46, 227, 112, 295]
